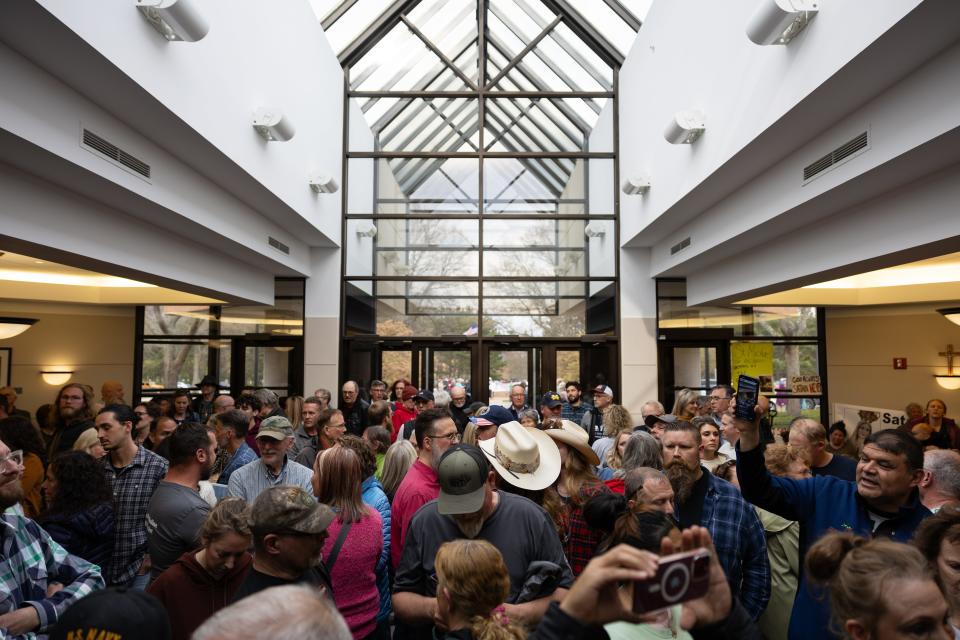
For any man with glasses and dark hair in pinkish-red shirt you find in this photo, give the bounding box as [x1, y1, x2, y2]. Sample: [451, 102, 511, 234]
[390, 408, 460, 569]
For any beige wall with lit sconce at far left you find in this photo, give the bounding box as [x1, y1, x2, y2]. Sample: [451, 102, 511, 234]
[0, 302, 136, 413]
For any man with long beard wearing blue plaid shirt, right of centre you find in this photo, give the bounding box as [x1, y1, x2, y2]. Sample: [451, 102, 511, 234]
[660, 420, 770, 620]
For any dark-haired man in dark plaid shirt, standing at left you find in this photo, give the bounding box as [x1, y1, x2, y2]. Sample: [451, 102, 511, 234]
[97, 404, 168, 589]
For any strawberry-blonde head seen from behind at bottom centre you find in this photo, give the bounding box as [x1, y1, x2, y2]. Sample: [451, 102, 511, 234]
[434, 540, 527, 640]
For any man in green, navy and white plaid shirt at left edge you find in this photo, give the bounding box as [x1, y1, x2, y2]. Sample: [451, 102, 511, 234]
[0, 442, 104, 638]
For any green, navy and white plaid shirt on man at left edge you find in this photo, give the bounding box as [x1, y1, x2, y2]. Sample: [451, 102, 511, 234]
[0, 513, 103, 638]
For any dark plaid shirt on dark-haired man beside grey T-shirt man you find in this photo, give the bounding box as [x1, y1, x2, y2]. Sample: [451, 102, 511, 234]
[101, 447, 169, 585]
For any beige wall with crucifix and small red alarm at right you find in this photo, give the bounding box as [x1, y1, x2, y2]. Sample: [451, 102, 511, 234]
[826, 305, 960, 417]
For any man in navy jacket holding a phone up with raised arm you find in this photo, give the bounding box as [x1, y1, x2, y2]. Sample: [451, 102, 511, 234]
[737, 408, 930, 640]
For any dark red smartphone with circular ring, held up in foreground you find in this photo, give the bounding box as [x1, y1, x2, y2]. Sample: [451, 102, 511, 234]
[633, 548, 710, 613]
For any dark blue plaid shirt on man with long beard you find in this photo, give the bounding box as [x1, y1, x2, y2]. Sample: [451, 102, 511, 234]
[700, 471, 770, 620]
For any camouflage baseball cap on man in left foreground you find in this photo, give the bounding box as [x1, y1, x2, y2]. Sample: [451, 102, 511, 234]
[250, 485, 334, 534]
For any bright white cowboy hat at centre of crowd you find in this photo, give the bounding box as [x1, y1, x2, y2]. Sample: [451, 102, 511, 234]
[478, 420, 560, 491]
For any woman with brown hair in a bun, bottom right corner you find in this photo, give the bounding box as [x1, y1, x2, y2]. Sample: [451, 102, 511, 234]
[806, 532, 954, 640]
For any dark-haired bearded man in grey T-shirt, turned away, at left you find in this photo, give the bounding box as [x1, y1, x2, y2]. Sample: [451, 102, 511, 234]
[146, 422, 217, 578]
